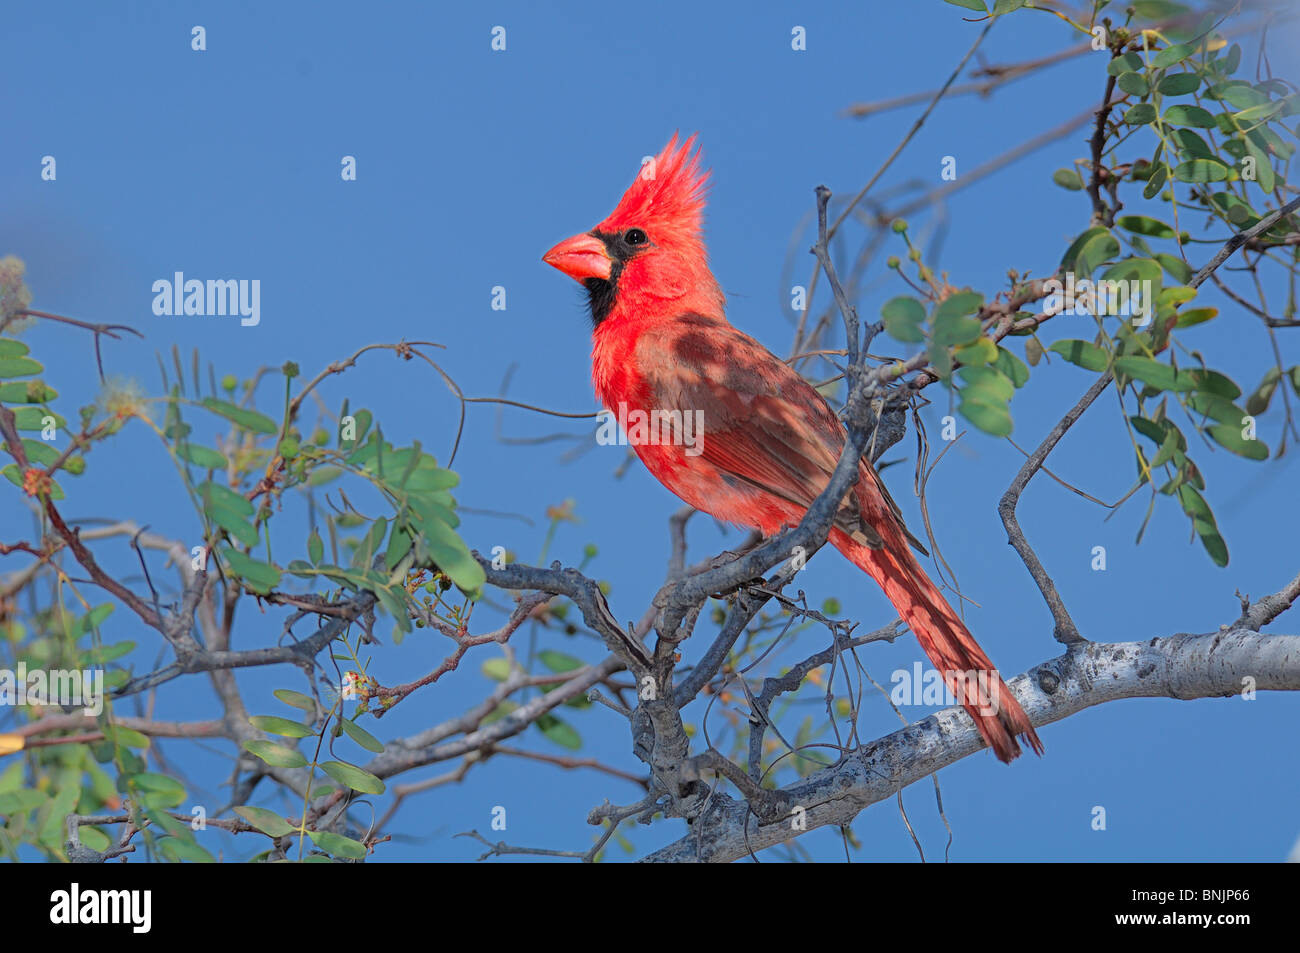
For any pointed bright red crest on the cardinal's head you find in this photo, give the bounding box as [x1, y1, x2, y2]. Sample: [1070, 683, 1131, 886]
[599, 133, 709, 238]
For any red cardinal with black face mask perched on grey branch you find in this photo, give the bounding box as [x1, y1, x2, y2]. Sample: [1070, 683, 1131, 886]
[543, 135, 1043, 761]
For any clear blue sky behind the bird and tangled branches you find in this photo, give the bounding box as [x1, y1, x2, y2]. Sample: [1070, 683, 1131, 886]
[0, 0, 1300, 861]
